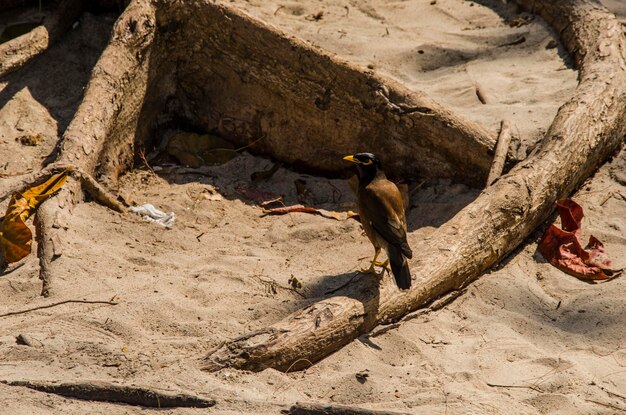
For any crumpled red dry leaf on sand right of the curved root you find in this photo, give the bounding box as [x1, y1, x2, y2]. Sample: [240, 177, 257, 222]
[538, 199, 613, 281]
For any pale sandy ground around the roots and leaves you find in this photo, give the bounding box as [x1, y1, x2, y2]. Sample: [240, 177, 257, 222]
[0, 0, 626, 414]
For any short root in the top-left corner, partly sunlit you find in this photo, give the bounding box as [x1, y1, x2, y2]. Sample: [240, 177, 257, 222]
[0, 0, 85, 77]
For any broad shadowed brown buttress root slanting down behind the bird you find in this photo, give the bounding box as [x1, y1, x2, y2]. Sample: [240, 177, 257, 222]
[157, 0, 495, 184]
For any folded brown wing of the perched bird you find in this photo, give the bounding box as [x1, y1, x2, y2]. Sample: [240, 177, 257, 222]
[360, 180, 410, 257]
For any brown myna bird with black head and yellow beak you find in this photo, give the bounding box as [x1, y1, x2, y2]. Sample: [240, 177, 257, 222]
[343, 153, 413, 290]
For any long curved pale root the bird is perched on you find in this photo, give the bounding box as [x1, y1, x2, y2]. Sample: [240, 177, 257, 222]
[204, 0, 626, 371]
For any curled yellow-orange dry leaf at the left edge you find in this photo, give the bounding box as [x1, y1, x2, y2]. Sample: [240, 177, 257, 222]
[0, 167, 72, 264]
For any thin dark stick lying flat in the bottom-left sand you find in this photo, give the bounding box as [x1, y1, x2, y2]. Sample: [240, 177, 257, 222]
[0, 380, 215, 408]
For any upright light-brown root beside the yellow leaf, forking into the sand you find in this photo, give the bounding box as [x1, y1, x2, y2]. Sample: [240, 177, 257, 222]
[25, 0, 155, 297]
